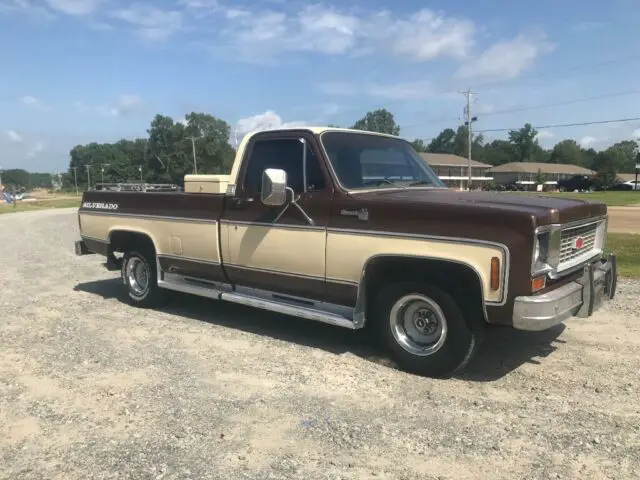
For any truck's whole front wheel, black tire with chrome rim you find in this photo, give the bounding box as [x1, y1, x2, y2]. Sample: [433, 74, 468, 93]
[371, 282, 480, 377]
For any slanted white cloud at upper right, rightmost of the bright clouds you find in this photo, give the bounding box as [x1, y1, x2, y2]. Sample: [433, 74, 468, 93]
[455, 33, 554, 80]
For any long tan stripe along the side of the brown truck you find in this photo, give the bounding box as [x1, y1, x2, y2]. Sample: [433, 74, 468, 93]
[80, 213, 507, 304]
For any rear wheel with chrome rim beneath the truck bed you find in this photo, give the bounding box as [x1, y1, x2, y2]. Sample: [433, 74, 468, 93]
[120, 250, 162, 308]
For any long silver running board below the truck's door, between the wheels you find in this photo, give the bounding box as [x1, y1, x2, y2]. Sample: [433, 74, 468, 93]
[158, 274, 359, 330]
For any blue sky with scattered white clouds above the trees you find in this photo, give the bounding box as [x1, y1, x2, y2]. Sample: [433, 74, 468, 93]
[0, 0, 640, 172]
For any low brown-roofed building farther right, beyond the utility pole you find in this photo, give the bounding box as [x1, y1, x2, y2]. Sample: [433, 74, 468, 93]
[488, 162, 596, 190]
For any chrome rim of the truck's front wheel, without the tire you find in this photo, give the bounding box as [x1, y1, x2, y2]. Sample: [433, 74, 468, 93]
[389, 293, 447, 357]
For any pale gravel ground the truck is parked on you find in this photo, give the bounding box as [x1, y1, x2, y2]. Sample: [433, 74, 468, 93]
[0, 210, 640, 480]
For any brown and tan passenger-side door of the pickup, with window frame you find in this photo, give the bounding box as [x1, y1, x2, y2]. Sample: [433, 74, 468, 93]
[221, 131, 333, 301]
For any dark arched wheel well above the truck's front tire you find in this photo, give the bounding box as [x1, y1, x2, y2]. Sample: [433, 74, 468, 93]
[363, 256, 487, 327]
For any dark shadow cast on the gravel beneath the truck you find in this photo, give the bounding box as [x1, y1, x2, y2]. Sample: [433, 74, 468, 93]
[74, 278, 565, 382]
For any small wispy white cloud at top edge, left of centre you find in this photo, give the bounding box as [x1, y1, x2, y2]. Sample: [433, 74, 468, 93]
[111, 3, 183, 40]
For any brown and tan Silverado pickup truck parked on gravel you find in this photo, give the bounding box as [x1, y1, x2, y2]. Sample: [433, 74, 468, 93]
[75, 127, 617, 376]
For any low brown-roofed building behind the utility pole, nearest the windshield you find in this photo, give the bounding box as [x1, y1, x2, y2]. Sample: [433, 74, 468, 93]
[420, 152, 493, 190]
